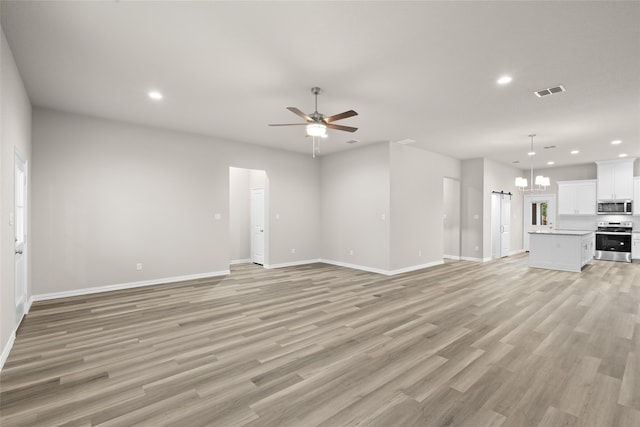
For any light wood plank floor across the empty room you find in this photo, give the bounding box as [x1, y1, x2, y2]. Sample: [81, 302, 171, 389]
[0, 254, 640, 427]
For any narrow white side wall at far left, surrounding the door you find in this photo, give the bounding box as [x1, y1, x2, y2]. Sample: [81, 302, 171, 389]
[0, 26, 33, 369]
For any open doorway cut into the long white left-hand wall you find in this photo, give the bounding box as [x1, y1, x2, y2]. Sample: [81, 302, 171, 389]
[229, 167, 269, 265]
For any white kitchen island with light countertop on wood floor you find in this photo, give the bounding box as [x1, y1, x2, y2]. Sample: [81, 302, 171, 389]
[529, 230, 595, 272]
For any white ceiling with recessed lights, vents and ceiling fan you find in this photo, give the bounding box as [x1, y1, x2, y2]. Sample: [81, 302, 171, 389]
[0, 0, 640, 169]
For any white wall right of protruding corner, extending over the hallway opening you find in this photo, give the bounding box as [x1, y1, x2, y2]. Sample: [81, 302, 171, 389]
[390, 143, 460, 271]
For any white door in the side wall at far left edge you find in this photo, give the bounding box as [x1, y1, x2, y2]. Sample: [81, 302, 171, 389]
[11, 153, 28, 322]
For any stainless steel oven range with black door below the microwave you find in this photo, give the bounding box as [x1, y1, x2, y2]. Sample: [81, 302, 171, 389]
[595, 221, 633, 262]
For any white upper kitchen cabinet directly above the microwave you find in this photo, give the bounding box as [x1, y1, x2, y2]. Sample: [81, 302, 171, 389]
[596, 159, 635, 200]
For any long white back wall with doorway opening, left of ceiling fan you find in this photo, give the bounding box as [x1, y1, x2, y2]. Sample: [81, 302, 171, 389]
[32, 108, 319, 294]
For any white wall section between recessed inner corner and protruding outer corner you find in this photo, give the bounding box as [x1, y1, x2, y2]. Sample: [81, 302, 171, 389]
[321, 142, 390, 271]
